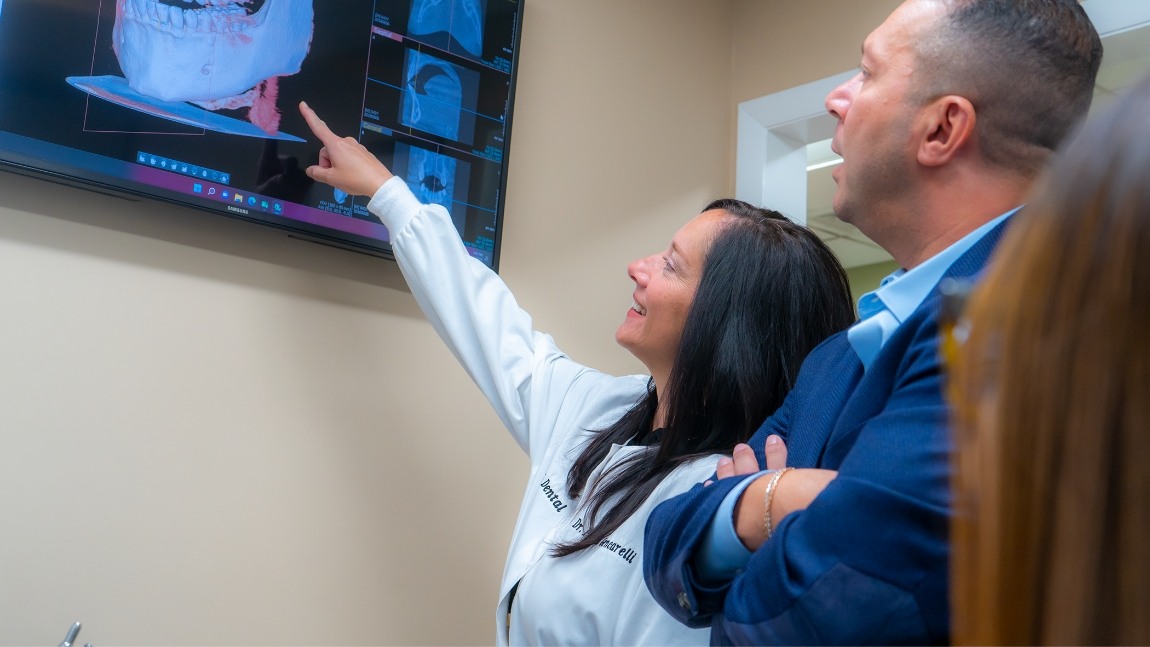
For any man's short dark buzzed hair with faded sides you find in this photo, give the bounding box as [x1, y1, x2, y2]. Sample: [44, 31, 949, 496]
[915, 0, 1102, 174]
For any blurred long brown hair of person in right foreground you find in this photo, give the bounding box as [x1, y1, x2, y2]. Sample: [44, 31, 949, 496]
[949, 78, 1150, 645]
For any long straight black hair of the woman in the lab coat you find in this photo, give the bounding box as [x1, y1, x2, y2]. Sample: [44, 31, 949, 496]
[552, 199, 854, 556]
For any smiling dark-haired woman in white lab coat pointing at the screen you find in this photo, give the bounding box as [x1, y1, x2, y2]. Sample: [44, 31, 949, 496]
[300, 105, 854, 645]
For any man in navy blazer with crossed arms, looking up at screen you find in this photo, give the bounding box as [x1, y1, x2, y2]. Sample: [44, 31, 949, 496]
[643, 0, 1102, 645]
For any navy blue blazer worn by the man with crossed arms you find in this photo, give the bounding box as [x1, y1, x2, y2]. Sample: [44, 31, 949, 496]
[643, 218, 1010, 645]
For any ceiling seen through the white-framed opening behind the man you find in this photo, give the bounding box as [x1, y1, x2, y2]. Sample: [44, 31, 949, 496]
[806, 19, 1150, 268]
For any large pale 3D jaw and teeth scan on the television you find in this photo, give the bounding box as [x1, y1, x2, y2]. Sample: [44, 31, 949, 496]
[113, 0, 314, 134]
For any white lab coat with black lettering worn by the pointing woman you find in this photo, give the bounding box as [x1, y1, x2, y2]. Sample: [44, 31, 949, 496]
[368, 178, 719, 645]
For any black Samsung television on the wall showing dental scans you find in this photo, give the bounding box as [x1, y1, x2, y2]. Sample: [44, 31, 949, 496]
[0, 0, 523, 269]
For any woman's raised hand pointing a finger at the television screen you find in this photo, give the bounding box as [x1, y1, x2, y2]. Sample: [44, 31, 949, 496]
[299, 101, 393, 197]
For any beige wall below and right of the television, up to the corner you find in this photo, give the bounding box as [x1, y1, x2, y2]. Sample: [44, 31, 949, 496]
[0, 0, 736, 645]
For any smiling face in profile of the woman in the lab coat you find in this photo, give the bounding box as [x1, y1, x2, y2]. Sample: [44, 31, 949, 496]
[615, 209, 728, 376]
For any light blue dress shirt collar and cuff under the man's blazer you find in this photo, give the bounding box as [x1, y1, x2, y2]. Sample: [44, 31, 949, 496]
[695, 208, 1019, 583]
